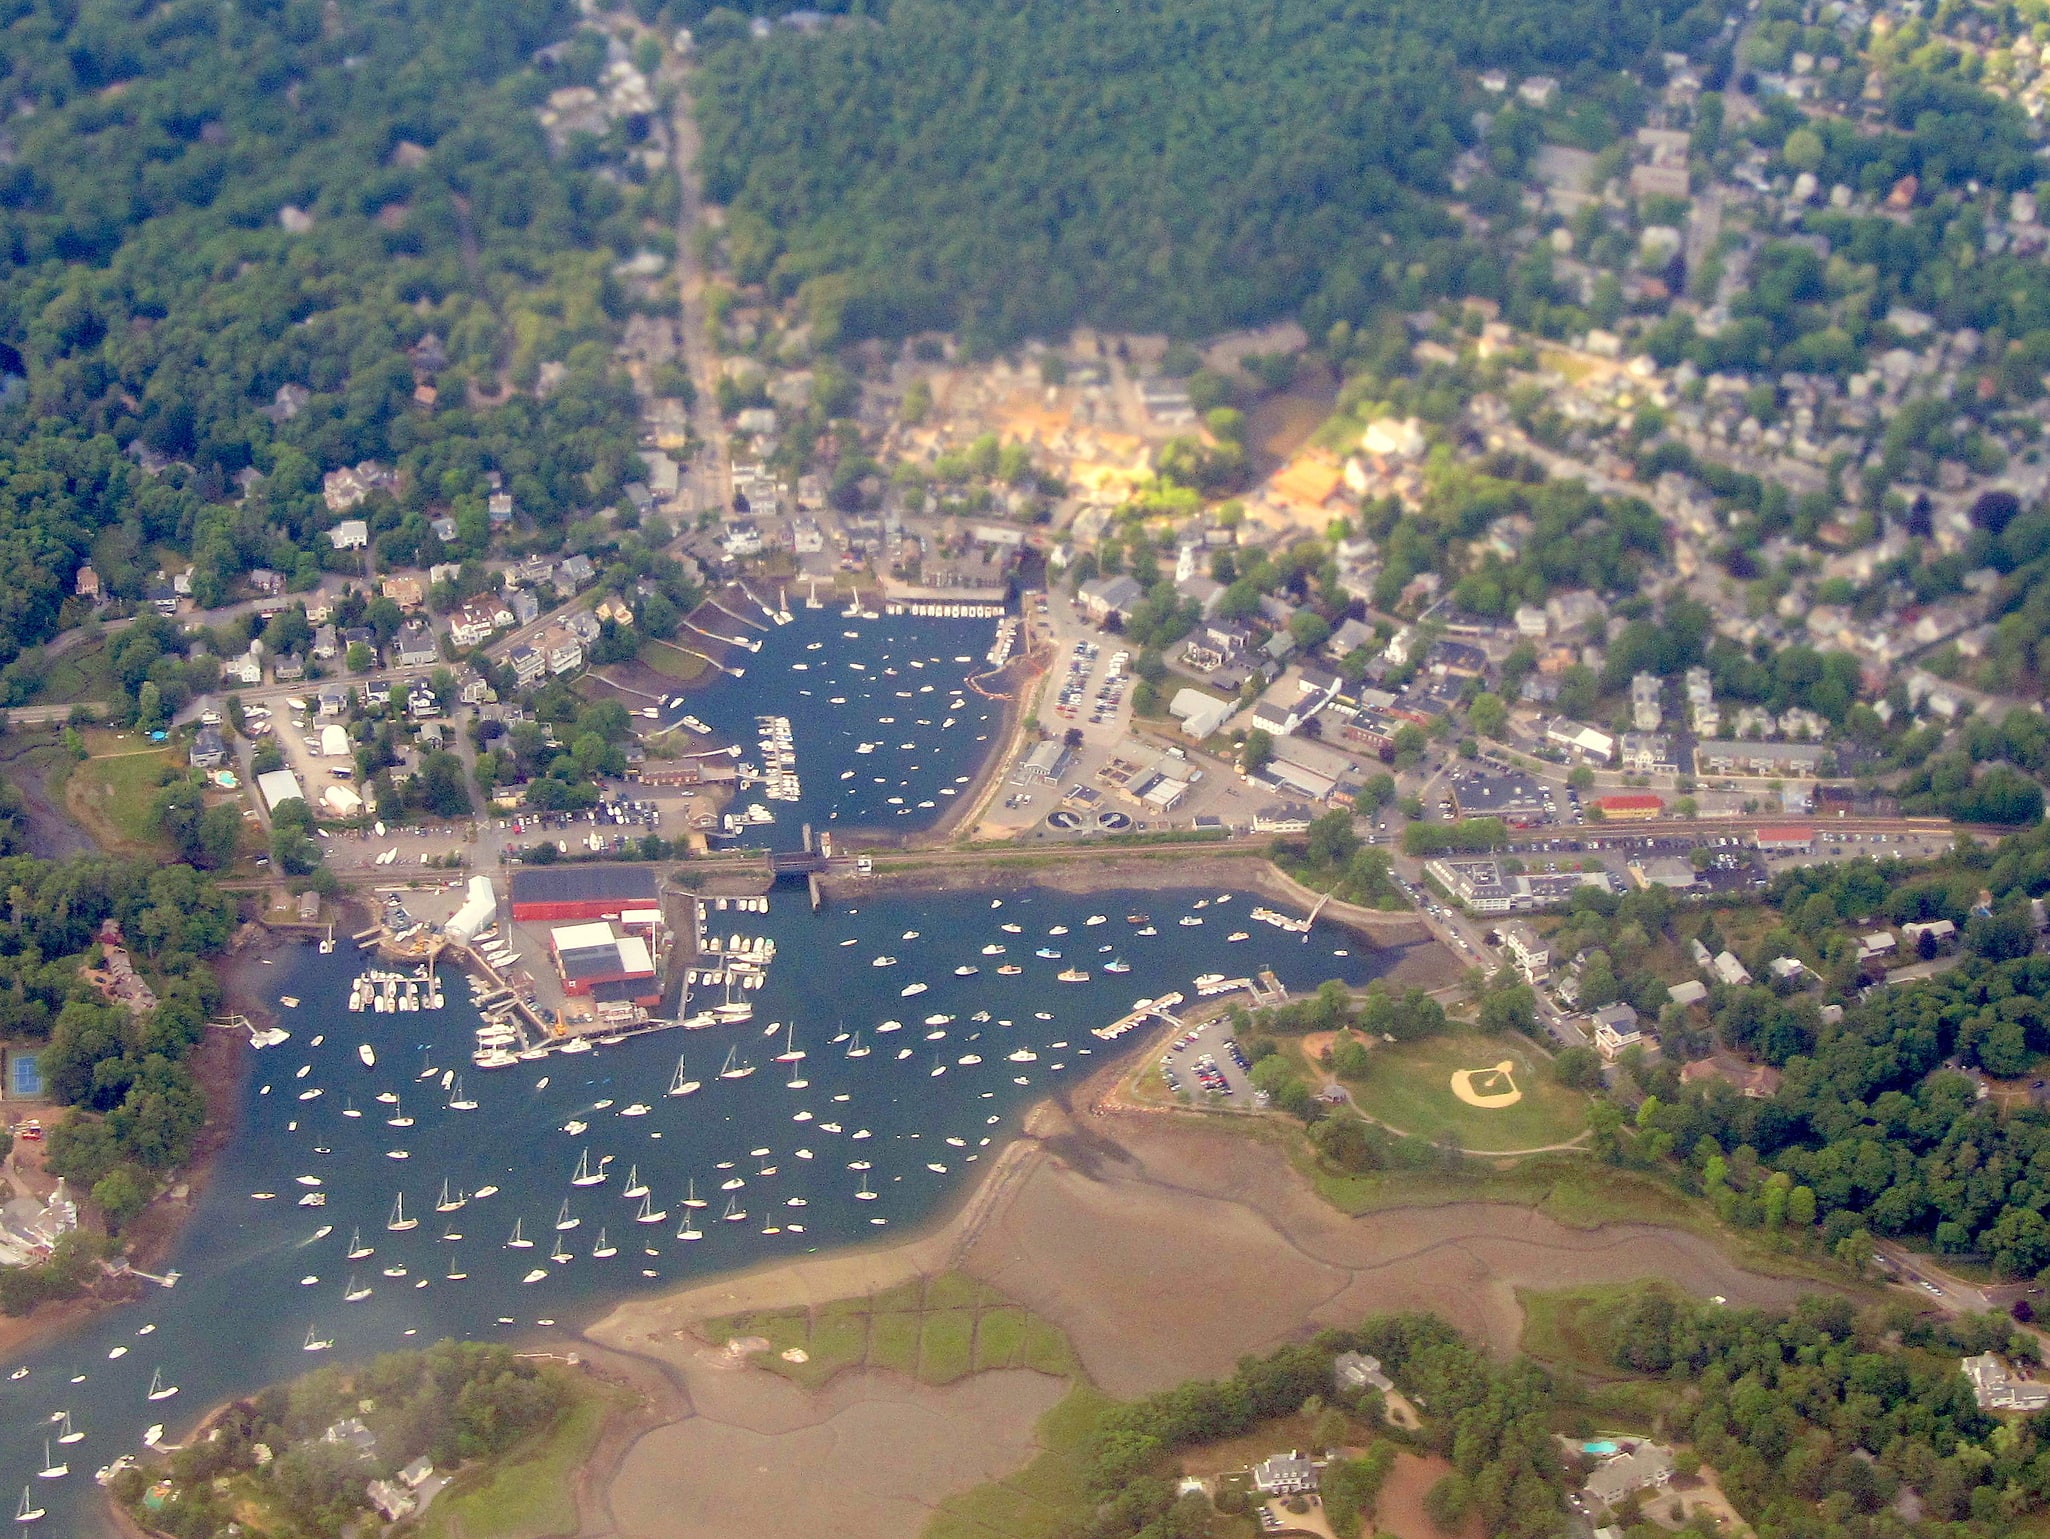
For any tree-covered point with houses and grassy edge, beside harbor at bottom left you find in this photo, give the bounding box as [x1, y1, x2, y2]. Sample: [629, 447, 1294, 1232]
[116, 1340, 619, 1539]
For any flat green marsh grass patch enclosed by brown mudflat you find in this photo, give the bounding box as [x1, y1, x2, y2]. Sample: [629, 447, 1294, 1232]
[701, 1273, 1076, 1389]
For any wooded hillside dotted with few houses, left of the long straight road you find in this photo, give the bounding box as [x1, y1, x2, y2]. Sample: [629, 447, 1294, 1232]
[0, 0, 674, 680]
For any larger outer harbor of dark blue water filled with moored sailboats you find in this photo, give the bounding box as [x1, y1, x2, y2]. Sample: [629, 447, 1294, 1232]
[0, 889, 1394, 1533]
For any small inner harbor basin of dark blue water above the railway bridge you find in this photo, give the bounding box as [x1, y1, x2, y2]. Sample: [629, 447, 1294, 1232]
[668, 600, 1002, 848]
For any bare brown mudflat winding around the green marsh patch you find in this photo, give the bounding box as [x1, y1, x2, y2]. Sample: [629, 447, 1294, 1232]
[588, 1107, 1814, 1539]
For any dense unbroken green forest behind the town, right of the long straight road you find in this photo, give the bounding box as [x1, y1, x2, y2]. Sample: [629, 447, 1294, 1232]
[699, 0, 1720, 342]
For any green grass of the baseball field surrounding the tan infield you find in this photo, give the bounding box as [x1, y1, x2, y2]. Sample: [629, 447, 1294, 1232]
[1345, 1031, 1587, 1152]
